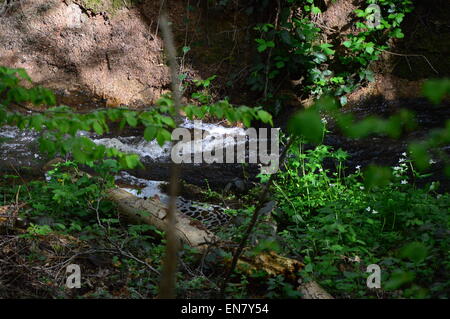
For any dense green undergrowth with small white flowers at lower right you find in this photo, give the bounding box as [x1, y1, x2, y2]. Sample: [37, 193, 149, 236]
[274, 144, 450, 297]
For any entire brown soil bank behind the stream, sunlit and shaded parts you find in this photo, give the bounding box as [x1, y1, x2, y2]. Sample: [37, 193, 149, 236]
[0, 0, 450, 107]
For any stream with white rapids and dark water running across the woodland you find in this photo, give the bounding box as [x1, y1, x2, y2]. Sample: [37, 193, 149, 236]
[0, 99, 450, 197]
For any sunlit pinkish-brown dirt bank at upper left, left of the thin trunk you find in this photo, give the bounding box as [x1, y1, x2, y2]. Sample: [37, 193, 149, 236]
[0, 0, 169, 105]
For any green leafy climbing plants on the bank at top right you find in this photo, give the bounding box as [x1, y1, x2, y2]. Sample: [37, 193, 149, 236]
[248, 0, 412, 109]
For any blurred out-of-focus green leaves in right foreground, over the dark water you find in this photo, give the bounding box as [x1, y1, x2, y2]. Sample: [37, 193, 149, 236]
[288, 89, 450, 183]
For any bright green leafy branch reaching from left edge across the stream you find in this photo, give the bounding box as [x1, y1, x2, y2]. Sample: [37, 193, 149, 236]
[0, 67, 272, 168]
